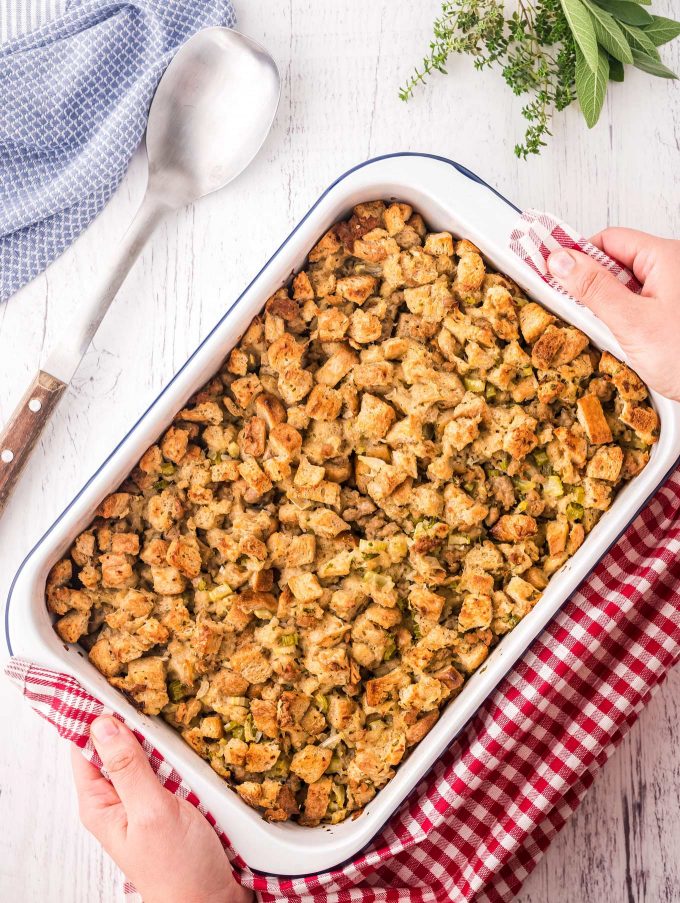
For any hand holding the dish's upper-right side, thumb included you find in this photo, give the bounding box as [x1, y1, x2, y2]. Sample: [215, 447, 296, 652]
[548, 229, 680, 401]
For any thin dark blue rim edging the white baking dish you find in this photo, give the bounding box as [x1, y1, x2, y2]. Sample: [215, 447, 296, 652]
[4, 151, 680, 672]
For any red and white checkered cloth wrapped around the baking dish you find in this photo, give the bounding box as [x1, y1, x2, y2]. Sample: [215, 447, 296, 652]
[8, 213, 680, 903]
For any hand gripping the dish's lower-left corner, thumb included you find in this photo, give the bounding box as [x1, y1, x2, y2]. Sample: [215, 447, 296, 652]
[71, 716, 252, 903]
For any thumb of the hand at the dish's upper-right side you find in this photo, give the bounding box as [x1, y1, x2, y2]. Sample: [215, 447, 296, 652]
[548, 248, 637, 335]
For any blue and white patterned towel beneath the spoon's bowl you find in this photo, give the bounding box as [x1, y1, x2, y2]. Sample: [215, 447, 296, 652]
[0, 0, 235, 301]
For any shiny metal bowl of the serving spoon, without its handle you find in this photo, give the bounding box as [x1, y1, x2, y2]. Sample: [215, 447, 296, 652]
[146, 27, 281, 207]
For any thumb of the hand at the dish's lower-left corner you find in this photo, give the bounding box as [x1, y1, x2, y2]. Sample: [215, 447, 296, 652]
[90, 715, 171, 818]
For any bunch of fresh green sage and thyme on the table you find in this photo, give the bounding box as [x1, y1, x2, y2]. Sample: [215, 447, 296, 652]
[399, 0, 680, 159]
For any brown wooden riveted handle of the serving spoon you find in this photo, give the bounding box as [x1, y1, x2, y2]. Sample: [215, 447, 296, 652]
[0, 370, 66, 514]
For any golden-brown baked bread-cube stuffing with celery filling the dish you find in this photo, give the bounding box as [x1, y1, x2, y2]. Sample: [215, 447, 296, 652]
[47, 201, 658, 825]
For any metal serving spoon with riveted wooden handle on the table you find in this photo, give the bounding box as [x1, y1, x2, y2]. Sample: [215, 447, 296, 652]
[0, 28, 281, 513]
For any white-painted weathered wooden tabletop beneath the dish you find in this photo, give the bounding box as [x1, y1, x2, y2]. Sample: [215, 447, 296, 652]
[0, 0, 680, 903]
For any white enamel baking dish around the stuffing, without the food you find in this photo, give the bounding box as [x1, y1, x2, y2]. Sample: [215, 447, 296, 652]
[7, 154, 680, 875]
